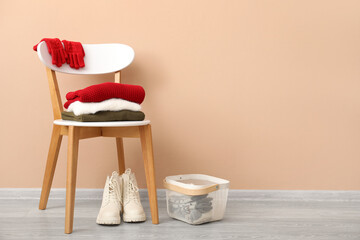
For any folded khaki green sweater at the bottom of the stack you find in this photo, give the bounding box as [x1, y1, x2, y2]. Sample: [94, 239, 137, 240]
[61, 110, 145, 122]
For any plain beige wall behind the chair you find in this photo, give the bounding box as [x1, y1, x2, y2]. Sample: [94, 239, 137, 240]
[0, 0, 360, 190]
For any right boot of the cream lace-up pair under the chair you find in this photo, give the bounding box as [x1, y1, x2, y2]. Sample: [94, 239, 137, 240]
[122, 168, 146, 222]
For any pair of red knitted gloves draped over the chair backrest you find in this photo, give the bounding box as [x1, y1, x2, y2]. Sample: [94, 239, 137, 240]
[33, 38, 85, 69]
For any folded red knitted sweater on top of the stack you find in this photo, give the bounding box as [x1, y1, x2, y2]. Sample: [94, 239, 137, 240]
[64, 82, 145, 108]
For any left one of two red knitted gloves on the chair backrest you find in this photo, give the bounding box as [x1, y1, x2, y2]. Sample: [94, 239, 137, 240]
[33, 38, 66, 67]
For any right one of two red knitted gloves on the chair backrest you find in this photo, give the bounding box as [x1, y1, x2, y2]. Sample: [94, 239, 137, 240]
[62, 40, 85, 69]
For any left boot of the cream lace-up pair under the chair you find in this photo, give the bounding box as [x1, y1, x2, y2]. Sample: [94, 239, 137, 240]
[96, 172, 122, 225]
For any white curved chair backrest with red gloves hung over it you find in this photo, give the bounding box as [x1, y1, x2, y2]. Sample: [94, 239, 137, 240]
[37, 42, 135, 74]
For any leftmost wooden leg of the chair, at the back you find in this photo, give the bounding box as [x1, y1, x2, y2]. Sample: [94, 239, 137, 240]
[39, 125, 62, 210]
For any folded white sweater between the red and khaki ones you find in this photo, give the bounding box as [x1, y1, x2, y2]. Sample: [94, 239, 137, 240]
[66, 98, 141, 116]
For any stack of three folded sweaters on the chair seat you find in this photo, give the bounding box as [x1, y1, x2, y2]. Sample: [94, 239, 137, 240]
[61, 82, 145, 122]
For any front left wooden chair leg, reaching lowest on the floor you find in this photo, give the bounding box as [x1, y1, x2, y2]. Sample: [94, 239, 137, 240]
[65, 126, 79, 233]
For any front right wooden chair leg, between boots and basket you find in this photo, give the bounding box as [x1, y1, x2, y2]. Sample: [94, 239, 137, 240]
[139, 124, 159, 224]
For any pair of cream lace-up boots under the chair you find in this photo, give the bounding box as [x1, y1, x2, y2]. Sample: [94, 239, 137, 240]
[96, 168, 146, 225]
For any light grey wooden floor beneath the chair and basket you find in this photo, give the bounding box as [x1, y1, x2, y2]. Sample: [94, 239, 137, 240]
[0, 191, 360, 240]
